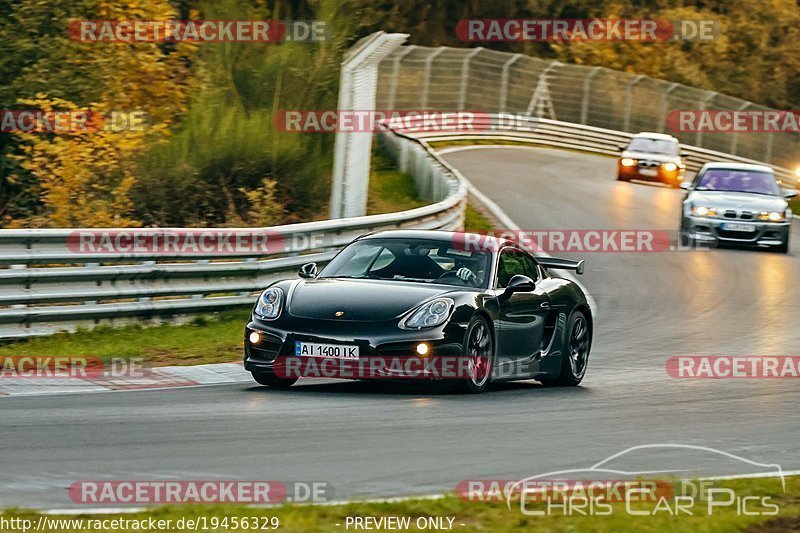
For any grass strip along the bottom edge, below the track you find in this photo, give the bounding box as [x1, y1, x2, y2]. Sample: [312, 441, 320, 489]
[0, 477, 800, 533]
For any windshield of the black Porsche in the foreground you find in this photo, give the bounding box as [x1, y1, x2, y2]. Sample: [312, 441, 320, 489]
[319, 239, 491, 287]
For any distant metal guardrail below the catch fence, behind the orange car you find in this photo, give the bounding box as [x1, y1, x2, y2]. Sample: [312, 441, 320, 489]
[407, 113, 800, 186]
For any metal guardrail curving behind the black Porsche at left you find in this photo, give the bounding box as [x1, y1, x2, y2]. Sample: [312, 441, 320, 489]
[0, 131, 467, 339]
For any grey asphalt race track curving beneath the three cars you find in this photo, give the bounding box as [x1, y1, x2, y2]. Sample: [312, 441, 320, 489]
[0, 148, 800, 508]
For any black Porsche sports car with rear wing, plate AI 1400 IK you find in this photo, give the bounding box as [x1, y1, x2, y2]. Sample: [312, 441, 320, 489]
[244, 230, 593, 393]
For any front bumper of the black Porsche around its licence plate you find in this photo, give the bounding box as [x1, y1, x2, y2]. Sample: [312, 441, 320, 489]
[244, 317, 467, 378]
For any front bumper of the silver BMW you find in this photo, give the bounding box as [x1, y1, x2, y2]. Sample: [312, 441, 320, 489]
[684, 216, 792, 246]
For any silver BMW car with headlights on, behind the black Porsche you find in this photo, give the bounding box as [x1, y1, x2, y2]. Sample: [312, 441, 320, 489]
[680, 163, 797, 253]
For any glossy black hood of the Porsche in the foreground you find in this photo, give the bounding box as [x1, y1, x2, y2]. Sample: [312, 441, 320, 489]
[287, 278, 457, 321]
